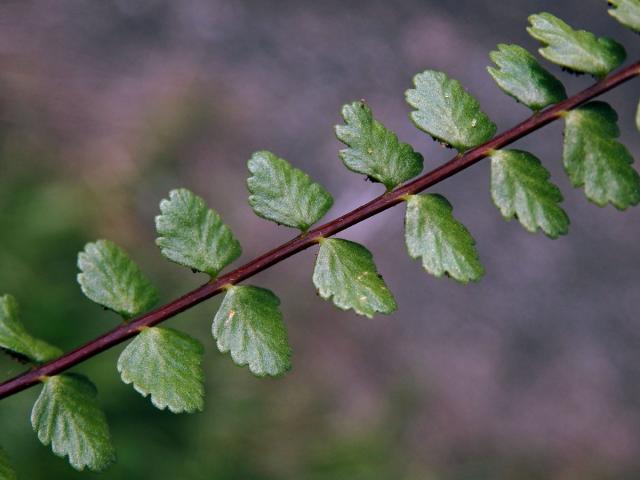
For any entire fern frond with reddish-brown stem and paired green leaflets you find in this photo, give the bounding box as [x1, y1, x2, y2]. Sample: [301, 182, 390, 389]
[0, 4, 640, 479]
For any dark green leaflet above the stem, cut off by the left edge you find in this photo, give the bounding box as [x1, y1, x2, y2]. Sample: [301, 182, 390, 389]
[0, 295, 62, 362]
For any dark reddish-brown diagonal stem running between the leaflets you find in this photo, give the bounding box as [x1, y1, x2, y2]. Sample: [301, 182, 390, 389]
[0, 62, 640, 399]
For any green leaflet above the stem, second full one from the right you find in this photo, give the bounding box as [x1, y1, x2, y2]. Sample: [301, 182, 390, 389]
[487, 43, 567, 110]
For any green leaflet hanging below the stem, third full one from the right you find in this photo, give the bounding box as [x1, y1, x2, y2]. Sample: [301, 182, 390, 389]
[405, 194, 484, 283]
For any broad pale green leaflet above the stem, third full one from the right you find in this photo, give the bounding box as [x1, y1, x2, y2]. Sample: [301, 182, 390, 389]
[405, 70, 496, 152]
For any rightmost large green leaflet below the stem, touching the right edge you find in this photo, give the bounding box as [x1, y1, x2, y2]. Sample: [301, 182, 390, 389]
[563, 102, 640, 210]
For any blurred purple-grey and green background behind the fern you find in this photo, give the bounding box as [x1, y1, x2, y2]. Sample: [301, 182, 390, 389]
[0, 0, 640, 480]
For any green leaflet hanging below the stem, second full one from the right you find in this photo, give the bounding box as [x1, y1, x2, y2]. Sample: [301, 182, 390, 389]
[491, 150, 569, 238]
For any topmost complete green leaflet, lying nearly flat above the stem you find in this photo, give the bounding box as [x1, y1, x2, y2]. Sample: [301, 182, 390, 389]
[527, 12, 627, 77]
